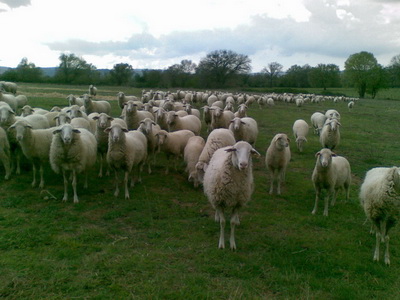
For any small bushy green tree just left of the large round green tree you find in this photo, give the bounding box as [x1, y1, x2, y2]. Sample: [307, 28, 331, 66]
[308, 64, 340, 90]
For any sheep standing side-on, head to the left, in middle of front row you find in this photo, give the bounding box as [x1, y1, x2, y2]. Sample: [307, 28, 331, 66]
[156, 129, 194, 174]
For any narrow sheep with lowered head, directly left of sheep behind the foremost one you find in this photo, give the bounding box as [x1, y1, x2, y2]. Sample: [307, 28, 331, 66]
[183, 136, 206, 188]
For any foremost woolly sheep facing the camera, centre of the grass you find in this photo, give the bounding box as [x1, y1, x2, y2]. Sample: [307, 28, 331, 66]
[204, 141, 260, 250]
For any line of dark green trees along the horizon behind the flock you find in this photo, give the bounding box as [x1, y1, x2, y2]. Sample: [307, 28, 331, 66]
[0, 50, 400, 98]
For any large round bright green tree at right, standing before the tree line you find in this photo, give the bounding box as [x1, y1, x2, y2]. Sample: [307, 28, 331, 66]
[344, 51, 383, 98]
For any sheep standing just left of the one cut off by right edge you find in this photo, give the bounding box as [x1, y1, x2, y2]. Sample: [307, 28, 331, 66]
[311, 148, 351, 216]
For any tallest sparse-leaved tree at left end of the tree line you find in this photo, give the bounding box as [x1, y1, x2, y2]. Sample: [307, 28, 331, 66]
[56, 53, 99, 84]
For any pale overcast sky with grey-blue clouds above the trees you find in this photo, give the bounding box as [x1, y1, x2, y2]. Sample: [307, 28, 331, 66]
[0, 0, 400, 72]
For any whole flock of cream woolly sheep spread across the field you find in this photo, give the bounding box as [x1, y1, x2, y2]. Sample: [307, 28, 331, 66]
[0, 82, 400, 264]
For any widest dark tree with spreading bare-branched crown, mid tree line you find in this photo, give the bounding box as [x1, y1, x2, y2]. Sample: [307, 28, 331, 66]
[196, 50, 251, 87]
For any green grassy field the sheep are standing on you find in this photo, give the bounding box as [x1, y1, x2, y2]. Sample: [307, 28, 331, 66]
[0, 85, 400, 299]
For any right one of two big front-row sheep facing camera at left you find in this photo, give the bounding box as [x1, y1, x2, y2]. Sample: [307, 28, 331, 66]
[105, 124, 147, 199]
